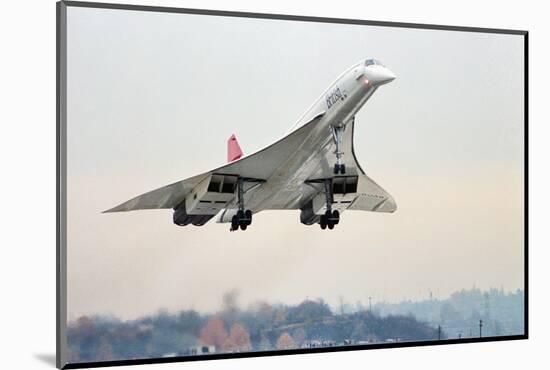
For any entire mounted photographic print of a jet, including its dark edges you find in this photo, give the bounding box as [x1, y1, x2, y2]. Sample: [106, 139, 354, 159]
[58, 2, 527, 368]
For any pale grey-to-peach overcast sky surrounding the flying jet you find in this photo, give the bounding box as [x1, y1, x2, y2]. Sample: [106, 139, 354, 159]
[67, 7, 524, 319]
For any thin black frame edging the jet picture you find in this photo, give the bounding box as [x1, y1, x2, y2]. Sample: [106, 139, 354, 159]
[56, 1, 529, 369]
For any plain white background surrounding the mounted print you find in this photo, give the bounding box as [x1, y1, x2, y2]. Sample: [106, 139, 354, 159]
[0, 0, 550, 369]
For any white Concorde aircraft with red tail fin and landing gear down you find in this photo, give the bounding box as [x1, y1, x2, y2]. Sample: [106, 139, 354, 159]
[105, 59, 397, 231]
